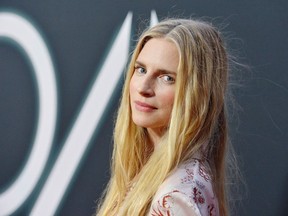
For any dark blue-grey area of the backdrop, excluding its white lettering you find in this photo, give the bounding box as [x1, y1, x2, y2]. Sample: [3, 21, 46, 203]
[0, 0, 288, 216]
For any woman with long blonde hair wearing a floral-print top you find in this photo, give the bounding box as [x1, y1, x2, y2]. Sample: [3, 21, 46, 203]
[97, 19, 233, 216]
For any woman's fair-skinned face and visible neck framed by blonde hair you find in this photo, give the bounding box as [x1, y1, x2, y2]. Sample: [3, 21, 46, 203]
[130, 38, 179, 145]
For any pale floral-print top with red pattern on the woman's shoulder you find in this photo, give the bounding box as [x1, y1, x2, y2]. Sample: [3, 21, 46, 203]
[147, 159, 219, 216]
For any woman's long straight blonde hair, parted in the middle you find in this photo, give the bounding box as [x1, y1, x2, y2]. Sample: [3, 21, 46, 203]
[97, 19, 228, 216]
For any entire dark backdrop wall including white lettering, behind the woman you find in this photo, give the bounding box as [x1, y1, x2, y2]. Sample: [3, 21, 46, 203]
[0, 0, 288, 216]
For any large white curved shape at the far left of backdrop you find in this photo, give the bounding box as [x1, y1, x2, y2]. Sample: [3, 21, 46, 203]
[0, 12, 57, 215]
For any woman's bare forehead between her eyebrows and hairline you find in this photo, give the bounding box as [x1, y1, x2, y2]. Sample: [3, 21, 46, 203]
[136, 38, 179, 72]
